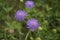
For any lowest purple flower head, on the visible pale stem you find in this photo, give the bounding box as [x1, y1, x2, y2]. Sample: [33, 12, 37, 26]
[27, 19, 39, 31]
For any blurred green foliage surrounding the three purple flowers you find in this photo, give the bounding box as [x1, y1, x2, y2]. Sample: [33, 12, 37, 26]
[0, 0, 60, 40]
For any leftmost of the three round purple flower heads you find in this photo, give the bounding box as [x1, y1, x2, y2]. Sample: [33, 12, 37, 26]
[15, 10, 27, 21]
